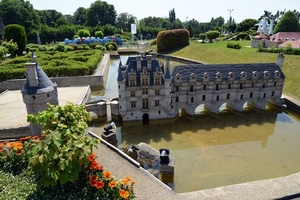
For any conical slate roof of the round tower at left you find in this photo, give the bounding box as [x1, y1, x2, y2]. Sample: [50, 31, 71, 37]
[21, 62, 54, 94]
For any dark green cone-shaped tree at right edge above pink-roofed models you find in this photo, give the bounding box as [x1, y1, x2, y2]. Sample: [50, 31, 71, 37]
[274, 11, 300, 34]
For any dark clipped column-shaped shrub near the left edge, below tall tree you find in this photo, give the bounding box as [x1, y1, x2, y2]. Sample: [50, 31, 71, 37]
[4, 24, 27, 54]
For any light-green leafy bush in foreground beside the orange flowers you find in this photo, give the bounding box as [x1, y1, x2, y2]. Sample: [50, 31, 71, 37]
[28, 103, 97, 186]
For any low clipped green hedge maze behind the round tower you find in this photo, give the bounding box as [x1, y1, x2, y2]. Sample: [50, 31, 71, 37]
[0, 50, 103, 82]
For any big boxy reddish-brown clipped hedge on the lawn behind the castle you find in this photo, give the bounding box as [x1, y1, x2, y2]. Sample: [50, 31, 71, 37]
[157, 29, 190, 52]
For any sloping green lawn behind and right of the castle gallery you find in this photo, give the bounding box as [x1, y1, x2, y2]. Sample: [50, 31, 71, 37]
[170, 41, 300, 99]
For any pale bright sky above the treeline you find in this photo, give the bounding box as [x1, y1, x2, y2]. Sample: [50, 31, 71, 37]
[28, 0, 300, 23]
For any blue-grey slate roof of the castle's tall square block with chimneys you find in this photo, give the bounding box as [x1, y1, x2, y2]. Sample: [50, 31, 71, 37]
[118, 56, 164, 87]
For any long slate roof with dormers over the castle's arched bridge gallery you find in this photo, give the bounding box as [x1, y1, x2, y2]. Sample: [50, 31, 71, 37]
[171, 63, 285, 82]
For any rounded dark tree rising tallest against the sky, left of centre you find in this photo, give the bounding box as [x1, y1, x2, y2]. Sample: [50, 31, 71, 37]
[86, 0, 117, 27]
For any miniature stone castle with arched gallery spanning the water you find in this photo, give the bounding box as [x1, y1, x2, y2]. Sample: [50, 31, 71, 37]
[117, 54, 285, 123]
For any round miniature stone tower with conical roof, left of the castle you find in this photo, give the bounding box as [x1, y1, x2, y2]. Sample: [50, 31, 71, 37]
[21, 53, 58, 135]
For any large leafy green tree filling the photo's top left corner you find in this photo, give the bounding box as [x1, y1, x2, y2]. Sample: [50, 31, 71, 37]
[0, 0, 41, 35]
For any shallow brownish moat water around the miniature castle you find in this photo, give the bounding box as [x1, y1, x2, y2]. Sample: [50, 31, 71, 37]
[86, 55, 300, 193]
